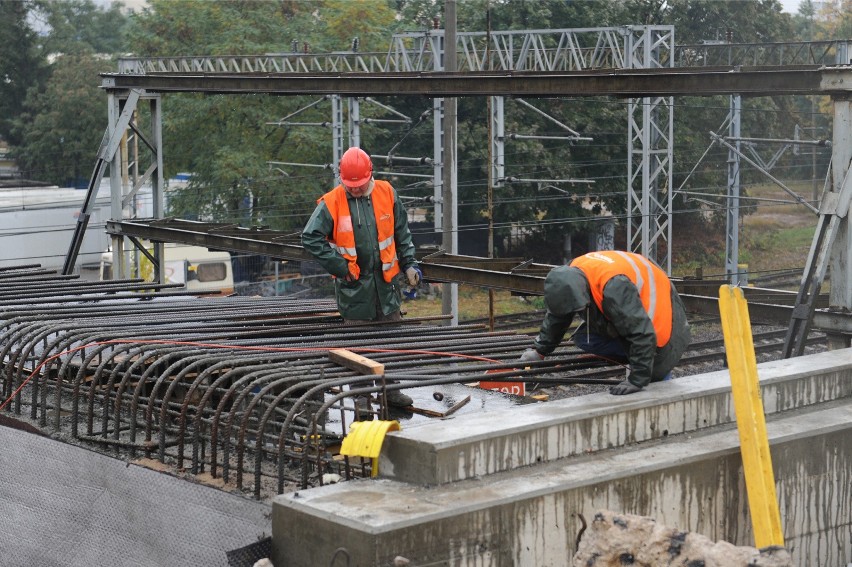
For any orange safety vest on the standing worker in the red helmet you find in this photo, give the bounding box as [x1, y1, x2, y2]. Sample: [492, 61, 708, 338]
[317, 180, 399, 283]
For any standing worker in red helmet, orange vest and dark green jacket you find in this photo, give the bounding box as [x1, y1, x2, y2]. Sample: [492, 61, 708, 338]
[302, 148, 423, 407]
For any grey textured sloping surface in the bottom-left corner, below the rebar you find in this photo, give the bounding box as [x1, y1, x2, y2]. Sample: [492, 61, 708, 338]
[0, 427, 271, 567]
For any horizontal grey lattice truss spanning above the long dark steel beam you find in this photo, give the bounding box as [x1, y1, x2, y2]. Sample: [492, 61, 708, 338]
[118, 38, 852, 75]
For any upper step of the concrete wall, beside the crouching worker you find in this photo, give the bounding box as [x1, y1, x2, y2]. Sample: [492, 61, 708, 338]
[379, 349, 852, 485]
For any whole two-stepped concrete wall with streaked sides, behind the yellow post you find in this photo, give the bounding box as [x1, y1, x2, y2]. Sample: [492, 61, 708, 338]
[272, 349, 852, 567]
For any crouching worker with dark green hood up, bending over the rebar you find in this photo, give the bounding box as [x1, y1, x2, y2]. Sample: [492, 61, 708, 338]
[521, 251, 690, 395]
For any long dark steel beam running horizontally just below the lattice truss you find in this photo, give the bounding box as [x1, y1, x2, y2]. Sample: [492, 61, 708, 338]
[101, 65, 840, 98]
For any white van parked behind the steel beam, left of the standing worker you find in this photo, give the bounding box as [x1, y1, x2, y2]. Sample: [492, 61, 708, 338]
[101, 242, 234, 295]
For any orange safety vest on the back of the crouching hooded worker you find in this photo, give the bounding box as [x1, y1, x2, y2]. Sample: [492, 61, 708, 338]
[571, 250, 672, 347]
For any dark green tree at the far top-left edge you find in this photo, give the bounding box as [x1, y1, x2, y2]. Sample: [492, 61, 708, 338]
[0, 0, 47, 146]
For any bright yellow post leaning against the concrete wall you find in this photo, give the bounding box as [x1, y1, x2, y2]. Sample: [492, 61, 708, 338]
[719, 285, 784, 548]
